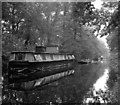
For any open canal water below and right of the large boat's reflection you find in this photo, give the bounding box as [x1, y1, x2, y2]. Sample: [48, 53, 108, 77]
[8, 60, 109, 104]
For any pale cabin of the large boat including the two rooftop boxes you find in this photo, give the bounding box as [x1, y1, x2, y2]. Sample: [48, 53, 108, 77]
[10, 46, 75, 62]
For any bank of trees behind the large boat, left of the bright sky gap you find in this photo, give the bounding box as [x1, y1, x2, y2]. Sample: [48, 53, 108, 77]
[2, 2, 105, 76]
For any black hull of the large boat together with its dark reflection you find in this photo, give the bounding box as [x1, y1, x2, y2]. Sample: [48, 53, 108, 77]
[9, 60, 74, 84]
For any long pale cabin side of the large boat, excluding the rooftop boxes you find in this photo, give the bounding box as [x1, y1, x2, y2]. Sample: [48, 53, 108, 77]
[10, 52, 74, 62]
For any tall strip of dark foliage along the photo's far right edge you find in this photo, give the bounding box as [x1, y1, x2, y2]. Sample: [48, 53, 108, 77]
[107, 2, 120, 103]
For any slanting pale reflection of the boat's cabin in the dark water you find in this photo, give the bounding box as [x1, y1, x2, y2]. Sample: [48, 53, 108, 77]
[9, 70, 74, 91]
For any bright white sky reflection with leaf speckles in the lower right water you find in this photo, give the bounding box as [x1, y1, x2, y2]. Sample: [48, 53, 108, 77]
[83, 68, 111, 104]
